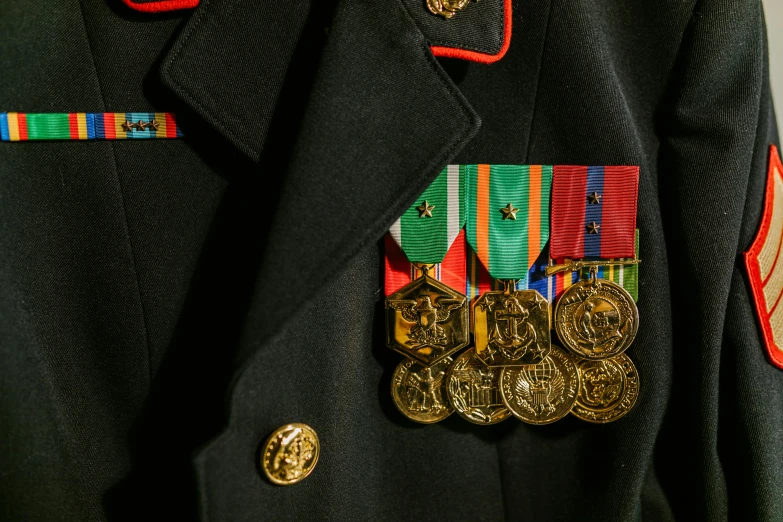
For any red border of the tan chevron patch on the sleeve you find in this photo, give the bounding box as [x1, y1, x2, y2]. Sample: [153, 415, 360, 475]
[743, 145, 783, 369]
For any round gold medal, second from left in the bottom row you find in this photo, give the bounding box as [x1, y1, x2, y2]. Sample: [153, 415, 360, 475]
[446, 348, 511, 425]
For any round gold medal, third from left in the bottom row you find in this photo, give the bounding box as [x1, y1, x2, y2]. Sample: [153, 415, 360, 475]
[500, 345, 579, 424]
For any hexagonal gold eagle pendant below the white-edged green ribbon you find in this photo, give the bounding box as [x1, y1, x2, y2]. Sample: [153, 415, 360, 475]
[386, 270, 470, 366]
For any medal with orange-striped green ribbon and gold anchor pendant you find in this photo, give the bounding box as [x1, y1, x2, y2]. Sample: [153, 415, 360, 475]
[465, 165, 552, 367]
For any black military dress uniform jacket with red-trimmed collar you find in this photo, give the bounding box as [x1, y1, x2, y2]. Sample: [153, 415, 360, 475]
[0, 0, 783, 522]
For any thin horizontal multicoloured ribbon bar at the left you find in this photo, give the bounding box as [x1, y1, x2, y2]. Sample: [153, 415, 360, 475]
[0, 112, 182, 141]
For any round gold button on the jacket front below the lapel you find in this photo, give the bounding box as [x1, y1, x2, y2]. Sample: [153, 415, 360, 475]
[261, 422, 321, 486]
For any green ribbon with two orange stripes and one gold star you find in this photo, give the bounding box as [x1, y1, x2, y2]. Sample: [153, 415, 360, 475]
[465, 165, 552, 285]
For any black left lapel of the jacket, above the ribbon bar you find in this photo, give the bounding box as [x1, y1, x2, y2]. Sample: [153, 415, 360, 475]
[161, 0, 310, 161]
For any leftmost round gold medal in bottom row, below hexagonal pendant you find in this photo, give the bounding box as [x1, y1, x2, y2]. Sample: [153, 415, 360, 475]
[392, 357, 454, 424]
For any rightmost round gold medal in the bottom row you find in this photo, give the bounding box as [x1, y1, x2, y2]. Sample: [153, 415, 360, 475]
[571, 354, 639, 424]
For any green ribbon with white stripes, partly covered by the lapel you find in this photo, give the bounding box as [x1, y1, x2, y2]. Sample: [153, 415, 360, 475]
[389, 165, 465, 264]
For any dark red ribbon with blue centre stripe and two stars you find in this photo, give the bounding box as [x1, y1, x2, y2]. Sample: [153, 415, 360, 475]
[550, 166, 639, 259]
